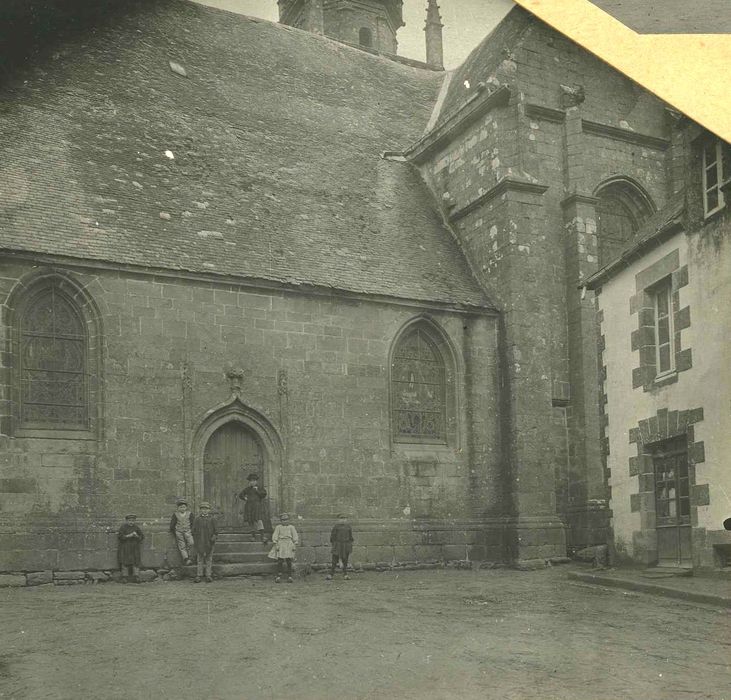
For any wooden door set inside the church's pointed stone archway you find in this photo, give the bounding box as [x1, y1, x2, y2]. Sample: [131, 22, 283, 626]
[203, 421, 265, 528]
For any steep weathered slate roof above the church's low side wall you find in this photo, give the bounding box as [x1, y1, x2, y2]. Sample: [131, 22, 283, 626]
[0, 0, 489, 306]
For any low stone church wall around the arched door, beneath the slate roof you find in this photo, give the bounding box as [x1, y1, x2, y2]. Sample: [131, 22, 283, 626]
[0, 259, 505, 570]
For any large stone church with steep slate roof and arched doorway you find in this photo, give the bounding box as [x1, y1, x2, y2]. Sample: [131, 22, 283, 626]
[0, 0, 728, 571]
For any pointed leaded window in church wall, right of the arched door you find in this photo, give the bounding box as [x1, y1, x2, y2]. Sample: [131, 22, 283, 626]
[391, 328, 447, 442]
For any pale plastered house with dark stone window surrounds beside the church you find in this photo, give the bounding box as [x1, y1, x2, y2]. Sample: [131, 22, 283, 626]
[588, 121, 731, 568]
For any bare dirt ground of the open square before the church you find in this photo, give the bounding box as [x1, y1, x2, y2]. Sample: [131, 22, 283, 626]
[0, 568, 731, 700]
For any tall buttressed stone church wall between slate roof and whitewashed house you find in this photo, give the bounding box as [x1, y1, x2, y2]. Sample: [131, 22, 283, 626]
[414, 13, 670, 549]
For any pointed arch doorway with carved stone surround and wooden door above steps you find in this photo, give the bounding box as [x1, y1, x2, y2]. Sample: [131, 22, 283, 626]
[192, 397, 283, 530]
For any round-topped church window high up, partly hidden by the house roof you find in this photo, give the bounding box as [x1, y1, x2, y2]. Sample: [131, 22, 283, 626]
[596, 179, 654, 266]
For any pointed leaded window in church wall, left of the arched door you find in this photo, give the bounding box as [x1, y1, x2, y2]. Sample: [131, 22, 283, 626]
[19, 289, 88, 430]
